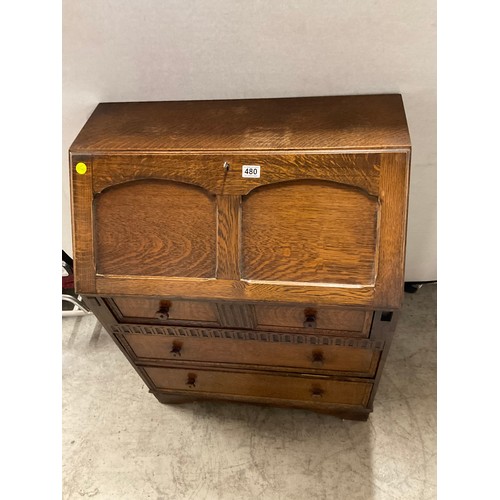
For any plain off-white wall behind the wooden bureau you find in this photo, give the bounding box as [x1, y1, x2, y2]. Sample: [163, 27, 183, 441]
[62, 0, 436, 281]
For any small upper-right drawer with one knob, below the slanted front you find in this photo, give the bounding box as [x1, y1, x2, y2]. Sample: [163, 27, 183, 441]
[255, 304, 373, 338]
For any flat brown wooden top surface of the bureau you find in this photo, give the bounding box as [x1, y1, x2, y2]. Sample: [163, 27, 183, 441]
[70, 94, 410, 153]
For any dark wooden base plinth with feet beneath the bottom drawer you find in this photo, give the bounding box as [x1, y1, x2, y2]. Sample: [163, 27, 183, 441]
[151, 391, 372, 422]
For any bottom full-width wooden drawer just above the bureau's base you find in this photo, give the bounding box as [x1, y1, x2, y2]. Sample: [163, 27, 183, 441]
[144, 367, 372, 406]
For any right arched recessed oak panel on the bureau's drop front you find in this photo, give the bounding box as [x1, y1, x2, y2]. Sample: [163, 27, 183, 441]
[241, 181, 379, 285]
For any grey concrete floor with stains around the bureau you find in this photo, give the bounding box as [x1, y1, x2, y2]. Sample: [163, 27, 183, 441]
[62, 285, 436, 500]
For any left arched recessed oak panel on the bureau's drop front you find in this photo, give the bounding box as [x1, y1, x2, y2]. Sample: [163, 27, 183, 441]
[94, 179, 217, 278]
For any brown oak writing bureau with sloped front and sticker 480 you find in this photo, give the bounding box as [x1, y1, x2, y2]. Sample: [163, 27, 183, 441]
[70, 95, 410, 420]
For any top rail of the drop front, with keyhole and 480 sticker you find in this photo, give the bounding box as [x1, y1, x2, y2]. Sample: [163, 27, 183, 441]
[93, 152, 380, 195]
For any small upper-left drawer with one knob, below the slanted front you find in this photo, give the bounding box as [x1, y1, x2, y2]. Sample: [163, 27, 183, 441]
[108, 297, 219, 326]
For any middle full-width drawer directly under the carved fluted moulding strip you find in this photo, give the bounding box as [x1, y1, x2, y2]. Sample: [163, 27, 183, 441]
[123, 333, 380, 377]
